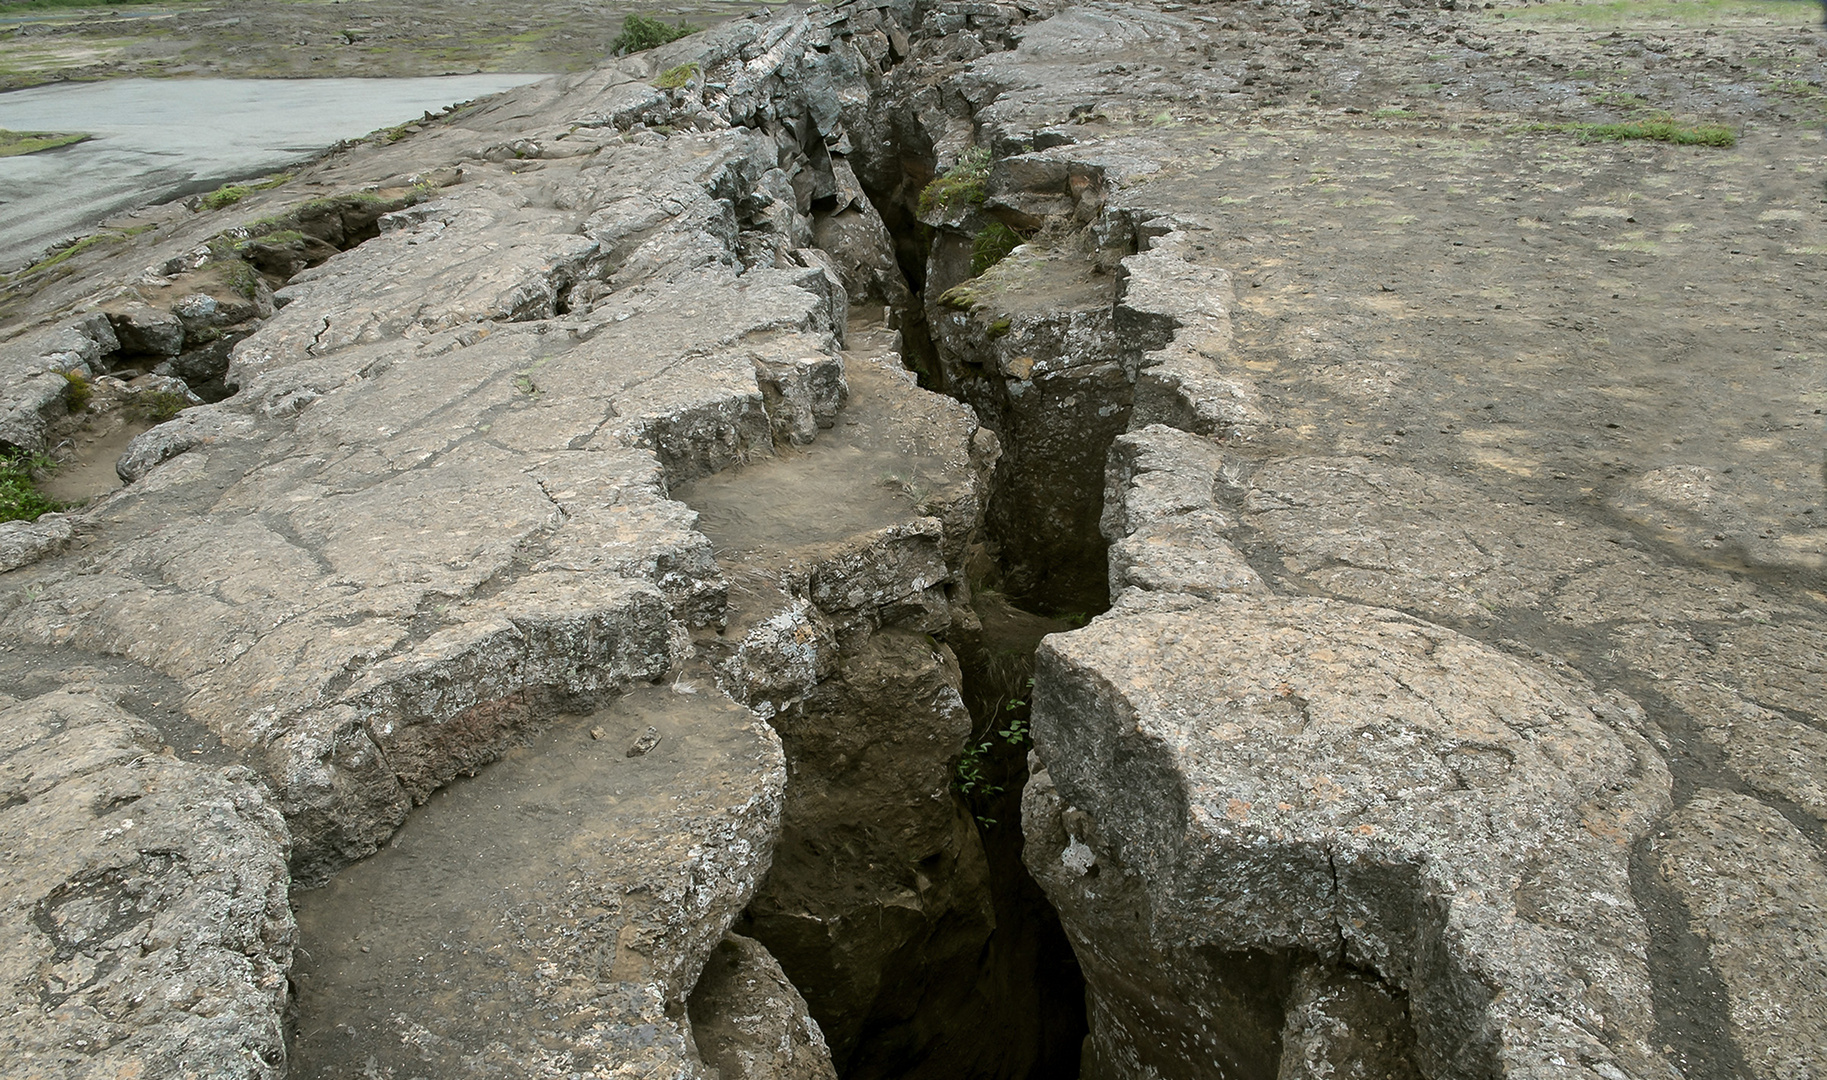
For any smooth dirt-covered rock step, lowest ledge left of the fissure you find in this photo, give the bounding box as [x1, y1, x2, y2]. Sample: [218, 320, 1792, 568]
[290, 676, 789, 1080]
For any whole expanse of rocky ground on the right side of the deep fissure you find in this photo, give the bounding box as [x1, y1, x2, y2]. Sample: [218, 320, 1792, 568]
[836, 4, 1823, 1076]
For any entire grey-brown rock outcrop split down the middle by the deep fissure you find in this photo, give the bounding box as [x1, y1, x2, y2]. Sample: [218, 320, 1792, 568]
[0, 2, 1827, 1080]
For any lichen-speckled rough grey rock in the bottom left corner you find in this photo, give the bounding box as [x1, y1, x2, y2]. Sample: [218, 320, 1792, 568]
[0, 683, 294, 1080]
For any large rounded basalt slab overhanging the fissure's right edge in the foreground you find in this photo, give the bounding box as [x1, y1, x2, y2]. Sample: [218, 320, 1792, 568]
[1023, 599, 1668, 1076]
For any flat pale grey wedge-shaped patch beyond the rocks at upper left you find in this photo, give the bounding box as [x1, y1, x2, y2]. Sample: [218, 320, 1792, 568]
[0, 73, 544, 269]
